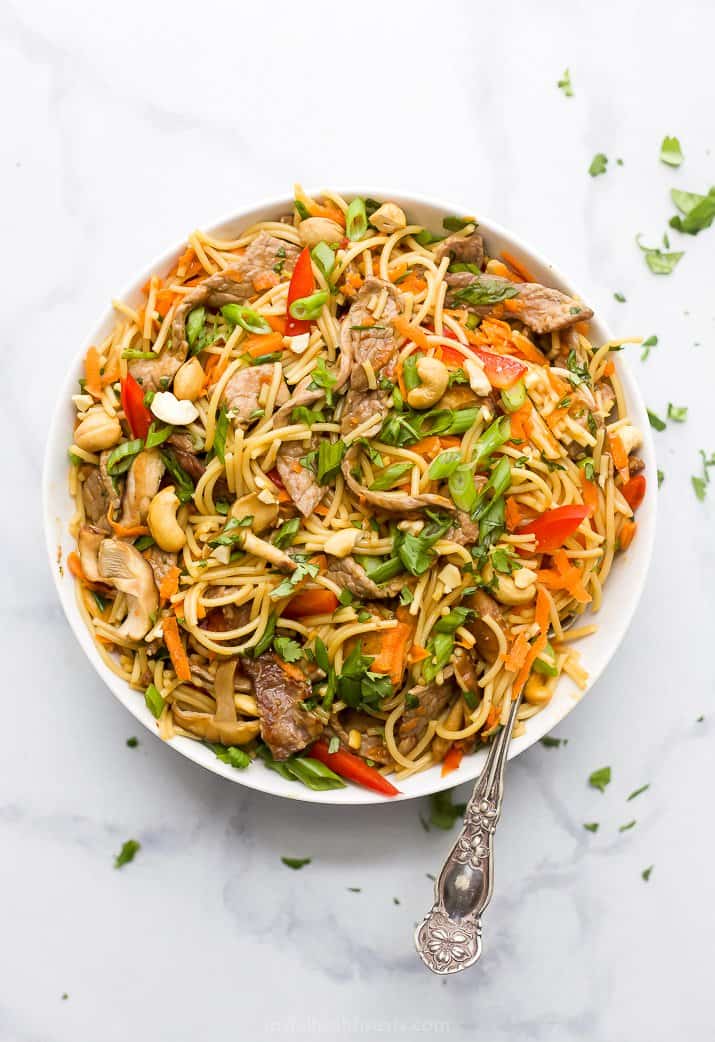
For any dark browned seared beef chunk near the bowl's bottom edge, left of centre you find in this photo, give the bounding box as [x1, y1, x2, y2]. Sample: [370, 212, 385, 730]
[242, 651, 323, 760]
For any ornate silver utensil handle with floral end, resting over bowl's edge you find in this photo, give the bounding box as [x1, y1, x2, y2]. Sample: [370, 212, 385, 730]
[415, 698, 521, 973]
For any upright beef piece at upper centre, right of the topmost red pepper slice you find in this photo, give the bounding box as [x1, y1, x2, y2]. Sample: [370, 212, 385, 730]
[341, 278, 401, 391]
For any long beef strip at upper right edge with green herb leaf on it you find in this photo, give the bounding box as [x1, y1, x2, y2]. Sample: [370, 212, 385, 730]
[445, 272, 593, 333]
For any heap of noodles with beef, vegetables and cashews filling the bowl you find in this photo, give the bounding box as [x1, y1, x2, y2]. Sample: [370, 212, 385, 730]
[69, 188, 645, 793]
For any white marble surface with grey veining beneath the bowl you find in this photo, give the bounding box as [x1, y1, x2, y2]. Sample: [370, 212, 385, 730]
[0, 0, 715, 1042]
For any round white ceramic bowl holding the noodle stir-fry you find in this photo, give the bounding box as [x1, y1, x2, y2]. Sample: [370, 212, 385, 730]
[43, 189, 657, 804]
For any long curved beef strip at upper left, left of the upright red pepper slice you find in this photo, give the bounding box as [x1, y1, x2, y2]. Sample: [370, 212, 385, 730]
[167, 231, 300, 362]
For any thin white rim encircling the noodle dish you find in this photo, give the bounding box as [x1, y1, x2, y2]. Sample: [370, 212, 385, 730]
[42, 187, 657, 807]
